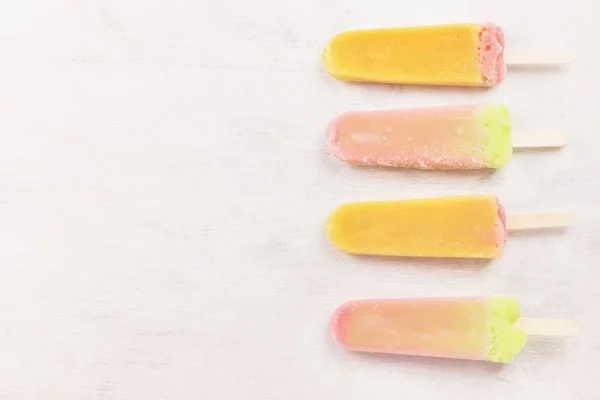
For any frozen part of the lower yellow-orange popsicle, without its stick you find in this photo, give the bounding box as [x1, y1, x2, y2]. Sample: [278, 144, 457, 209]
[326, 195, 507, 258]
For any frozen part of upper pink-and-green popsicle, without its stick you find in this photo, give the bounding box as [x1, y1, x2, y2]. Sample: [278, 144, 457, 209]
[326, 104, 513, 169]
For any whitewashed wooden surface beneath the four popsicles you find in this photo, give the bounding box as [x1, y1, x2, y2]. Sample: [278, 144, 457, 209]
[0, 0, 600, 400]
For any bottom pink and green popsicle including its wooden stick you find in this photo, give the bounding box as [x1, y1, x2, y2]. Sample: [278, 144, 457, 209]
[330, 297, 577, 363]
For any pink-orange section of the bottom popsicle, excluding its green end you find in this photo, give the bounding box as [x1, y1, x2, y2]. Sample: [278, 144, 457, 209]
[330, 298, 487, 360]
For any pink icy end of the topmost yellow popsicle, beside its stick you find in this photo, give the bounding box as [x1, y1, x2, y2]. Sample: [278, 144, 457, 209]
[477, 23, 506, 86]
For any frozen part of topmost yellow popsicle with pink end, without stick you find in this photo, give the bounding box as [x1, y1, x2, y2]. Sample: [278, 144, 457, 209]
[322, 23, 506, 86]
